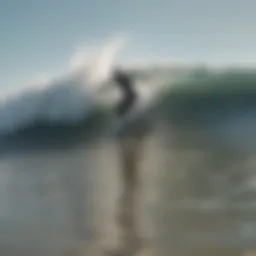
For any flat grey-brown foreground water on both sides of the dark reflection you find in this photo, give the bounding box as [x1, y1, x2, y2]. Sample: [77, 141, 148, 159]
[0, 115, 256, 256]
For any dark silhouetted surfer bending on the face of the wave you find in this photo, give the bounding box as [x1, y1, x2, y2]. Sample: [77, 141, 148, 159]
[114, 71, 136, 118]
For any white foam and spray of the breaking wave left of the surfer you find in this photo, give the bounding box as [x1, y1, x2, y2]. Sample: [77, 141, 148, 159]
[0, 39, 125, 134]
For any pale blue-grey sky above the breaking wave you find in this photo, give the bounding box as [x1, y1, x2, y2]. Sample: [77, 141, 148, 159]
[0, 0, 256, 88]
